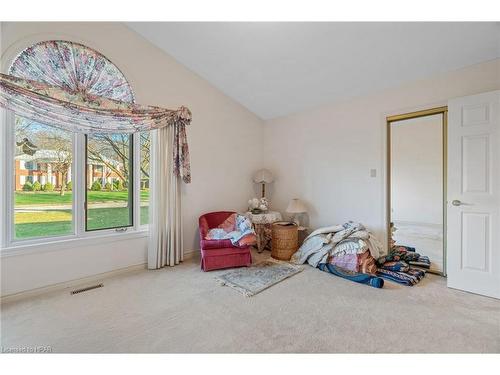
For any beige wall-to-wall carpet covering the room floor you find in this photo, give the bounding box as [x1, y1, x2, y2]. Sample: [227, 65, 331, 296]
[1, 252, 500, 353]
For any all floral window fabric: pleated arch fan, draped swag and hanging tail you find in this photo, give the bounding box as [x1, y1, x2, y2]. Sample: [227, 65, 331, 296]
[0, 41, 191, 183]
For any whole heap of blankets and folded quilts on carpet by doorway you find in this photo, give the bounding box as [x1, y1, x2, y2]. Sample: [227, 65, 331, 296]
[291, 221, 430, 288]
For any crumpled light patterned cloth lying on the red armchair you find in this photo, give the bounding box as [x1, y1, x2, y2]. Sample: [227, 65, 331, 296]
[205, 214, 257, 246]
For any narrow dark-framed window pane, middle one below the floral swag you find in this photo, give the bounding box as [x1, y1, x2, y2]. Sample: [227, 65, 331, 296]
[86, 134, 133, 230]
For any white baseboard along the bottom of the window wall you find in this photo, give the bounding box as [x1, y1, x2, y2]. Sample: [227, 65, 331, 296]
[0, 250, 199, 303]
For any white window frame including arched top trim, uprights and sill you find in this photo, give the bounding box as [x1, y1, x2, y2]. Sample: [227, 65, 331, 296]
[0, 39, 148, 253]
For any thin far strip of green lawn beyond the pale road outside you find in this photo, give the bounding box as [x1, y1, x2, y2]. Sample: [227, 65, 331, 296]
[15, 190, 149, 206]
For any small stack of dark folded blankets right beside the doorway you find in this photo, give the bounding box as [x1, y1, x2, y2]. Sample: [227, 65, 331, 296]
[377, 245, 431, 286]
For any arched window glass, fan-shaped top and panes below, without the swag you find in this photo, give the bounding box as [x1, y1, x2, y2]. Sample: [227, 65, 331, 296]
[9, 40, 149, 241]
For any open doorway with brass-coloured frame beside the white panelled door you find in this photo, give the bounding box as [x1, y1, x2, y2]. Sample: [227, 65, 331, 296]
[387, 107, 448, 276]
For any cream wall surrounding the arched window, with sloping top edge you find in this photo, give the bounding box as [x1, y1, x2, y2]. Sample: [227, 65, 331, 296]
[1, 23, 263, 295]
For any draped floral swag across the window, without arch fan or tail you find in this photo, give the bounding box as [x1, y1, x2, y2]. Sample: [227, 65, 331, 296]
[0, 73, 191, 133]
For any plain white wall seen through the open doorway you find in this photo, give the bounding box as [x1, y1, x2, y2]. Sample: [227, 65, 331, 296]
[391, 114, 443, 225]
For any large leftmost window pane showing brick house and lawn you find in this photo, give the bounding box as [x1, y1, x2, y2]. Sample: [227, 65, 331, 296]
[14, 116, 73, 239]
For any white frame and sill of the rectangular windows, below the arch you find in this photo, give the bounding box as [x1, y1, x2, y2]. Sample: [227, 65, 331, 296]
[0, 109, 149, 257]
